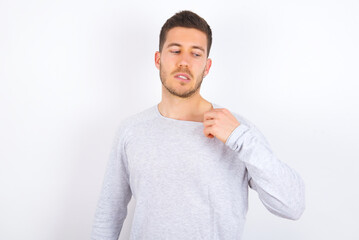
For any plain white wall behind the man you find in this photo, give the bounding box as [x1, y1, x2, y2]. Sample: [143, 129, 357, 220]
[0, 0, 359, 240]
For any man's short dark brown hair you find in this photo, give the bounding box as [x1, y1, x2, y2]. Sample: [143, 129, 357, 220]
[159, 10, 212, 57]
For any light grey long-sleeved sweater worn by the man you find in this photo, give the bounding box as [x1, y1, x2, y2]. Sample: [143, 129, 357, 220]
[92, 103, 305, 240]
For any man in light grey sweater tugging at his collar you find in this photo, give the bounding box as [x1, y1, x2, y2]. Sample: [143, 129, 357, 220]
[92, 11, 304, 240]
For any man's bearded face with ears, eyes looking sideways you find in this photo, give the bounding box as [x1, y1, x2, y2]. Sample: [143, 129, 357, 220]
[155, 27, 212, 98]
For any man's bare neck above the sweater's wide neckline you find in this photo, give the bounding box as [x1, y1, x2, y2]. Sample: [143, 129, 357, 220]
[158, 89, 212, 122]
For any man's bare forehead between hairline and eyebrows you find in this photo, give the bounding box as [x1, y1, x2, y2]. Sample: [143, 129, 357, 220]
[164, 27, 207, 49]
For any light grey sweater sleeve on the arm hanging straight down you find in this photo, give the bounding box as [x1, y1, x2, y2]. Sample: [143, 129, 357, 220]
[91, 124, 132, 240]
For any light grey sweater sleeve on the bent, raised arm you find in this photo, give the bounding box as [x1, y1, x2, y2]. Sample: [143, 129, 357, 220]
[225, 123, 305, 220]
